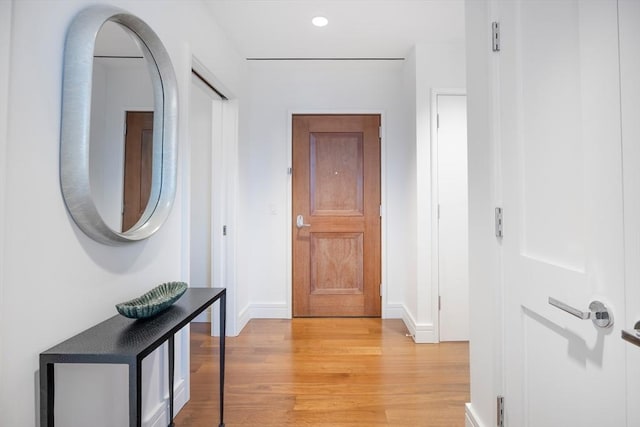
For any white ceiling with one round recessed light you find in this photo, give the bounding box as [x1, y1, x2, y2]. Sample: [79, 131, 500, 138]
[205, 0, 464, 58]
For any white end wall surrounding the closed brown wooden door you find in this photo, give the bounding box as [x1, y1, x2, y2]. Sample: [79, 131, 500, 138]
[238, 61, 415, 319]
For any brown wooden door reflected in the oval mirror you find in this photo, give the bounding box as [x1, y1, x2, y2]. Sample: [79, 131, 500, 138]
[122, 111, 153, 231]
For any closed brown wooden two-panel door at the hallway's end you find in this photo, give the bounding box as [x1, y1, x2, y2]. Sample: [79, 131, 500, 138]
[292, 115, 381, 317]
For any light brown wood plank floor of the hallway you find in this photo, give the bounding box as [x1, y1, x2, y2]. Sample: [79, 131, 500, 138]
[175, 318, 469, 427]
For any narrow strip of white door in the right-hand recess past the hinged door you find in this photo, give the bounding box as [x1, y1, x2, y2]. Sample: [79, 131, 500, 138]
[435, 93, 469, 341]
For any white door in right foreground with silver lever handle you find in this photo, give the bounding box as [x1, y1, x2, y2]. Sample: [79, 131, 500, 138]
[495, 0, 628, 427]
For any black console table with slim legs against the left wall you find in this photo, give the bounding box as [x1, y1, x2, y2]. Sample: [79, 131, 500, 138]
[40, 288, 226, 427]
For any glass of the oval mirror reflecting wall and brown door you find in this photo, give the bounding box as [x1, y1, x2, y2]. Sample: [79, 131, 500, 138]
[89, 21, 154, 231]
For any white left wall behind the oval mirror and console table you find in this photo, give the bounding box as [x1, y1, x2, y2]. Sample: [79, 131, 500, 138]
[0, 0, 245, 427]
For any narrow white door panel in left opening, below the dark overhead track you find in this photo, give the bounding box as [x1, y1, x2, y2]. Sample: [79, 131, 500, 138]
[189, 75, 225, 325]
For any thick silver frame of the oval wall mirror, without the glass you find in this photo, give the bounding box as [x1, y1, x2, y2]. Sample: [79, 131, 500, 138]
[60, 5, 178, 245]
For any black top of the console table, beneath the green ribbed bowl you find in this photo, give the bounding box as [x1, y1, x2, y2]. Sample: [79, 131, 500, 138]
[40, 288, 226, 363]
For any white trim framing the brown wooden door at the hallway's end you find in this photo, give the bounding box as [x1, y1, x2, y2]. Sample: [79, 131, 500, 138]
[285, 108, 388, 319]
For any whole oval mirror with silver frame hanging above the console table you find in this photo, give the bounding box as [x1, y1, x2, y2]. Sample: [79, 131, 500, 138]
[60, 6, 177, 244]
